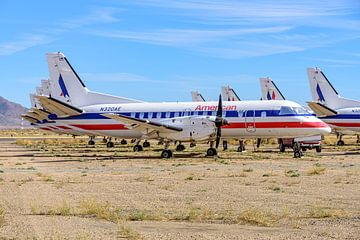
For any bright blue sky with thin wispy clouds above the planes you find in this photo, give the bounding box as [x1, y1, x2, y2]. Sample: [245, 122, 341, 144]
[0, 0, 360, 106]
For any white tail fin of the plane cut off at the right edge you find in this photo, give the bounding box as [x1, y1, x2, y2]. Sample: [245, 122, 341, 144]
[307, 68, 360, 109]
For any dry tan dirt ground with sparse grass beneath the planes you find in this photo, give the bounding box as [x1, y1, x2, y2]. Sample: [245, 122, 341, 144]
[0, 134, 360, 239]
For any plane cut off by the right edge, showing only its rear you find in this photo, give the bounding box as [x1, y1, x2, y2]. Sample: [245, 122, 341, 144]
[307, 68, 360, 146]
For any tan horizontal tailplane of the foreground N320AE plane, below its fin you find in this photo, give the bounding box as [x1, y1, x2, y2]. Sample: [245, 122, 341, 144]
[36, 96, 83, 116]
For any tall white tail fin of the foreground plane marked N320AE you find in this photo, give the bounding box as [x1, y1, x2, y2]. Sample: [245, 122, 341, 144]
[47, 52, 142, 107]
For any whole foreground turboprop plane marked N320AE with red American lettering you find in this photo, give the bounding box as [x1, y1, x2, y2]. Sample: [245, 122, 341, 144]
[38, 53, 330, 158]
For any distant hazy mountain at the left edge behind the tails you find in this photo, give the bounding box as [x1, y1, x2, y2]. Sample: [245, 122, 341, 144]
[0, 96, 29, 128]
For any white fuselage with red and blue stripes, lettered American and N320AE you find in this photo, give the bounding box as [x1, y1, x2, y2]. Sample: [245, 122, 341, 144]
[52, 101, 330, 141]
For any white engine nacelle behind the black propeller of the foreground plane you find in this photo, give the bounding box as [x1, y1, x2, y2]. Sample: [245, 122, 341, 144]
[159, 116, 216, 142]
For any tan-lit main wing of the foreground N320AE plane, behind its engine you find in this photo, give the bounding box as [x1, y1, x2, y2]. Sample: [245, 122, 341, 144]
[101, 113, 183, 134]
